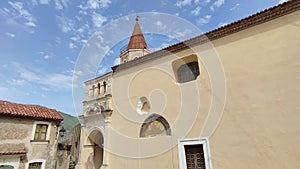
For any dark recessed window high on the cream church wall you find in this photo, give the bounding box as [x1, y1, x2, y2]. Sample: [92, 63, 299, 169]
[177, 62, 200, 83]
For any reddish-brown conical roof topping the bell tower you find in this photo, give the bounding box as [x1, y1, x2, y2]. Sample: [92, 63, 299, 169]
[127, 17, 149, 50]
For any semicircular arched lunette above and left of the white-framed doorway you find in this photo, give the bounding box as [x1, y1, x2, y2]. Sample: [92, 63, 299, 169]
[140, 114, 171, 137]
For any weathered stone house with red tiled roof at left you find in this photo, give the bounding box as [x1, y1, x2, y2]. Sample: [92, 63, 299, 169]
[0, 101, 63, 169]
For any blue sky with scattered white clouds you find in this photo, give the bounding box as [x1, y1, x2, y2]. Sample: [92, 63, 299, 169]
[0, 0, 284, 116]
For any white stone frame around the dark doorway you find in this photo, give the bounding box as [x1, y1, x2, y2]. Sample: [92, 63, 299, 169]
[178, 138, 212, 169]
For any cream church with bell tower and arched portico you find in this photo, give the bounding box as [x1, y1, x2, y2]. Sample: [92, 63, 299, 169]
[76, 0, 300, 169]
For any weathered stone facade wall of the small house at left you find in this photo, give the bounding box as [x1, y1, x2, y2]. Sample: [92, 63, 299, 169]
[0, 117, 57, 169]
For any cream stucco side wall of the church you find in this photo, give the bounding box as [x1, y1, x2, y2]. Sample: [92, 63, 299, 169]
[76, 11, 300, 169]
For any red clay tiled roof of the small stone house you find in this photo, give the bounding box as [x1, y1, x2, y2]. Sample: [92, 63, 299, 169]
[0, 101, 63, 121]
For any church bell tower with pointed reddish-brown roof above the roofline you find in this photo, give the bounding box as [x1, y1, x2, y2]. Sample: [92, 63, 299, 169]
[120, 16, 150, 63]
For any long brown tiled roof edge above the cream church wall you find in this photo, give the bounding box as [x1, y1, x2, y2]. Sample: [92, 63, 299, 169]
[112, 0, 300, 72]
